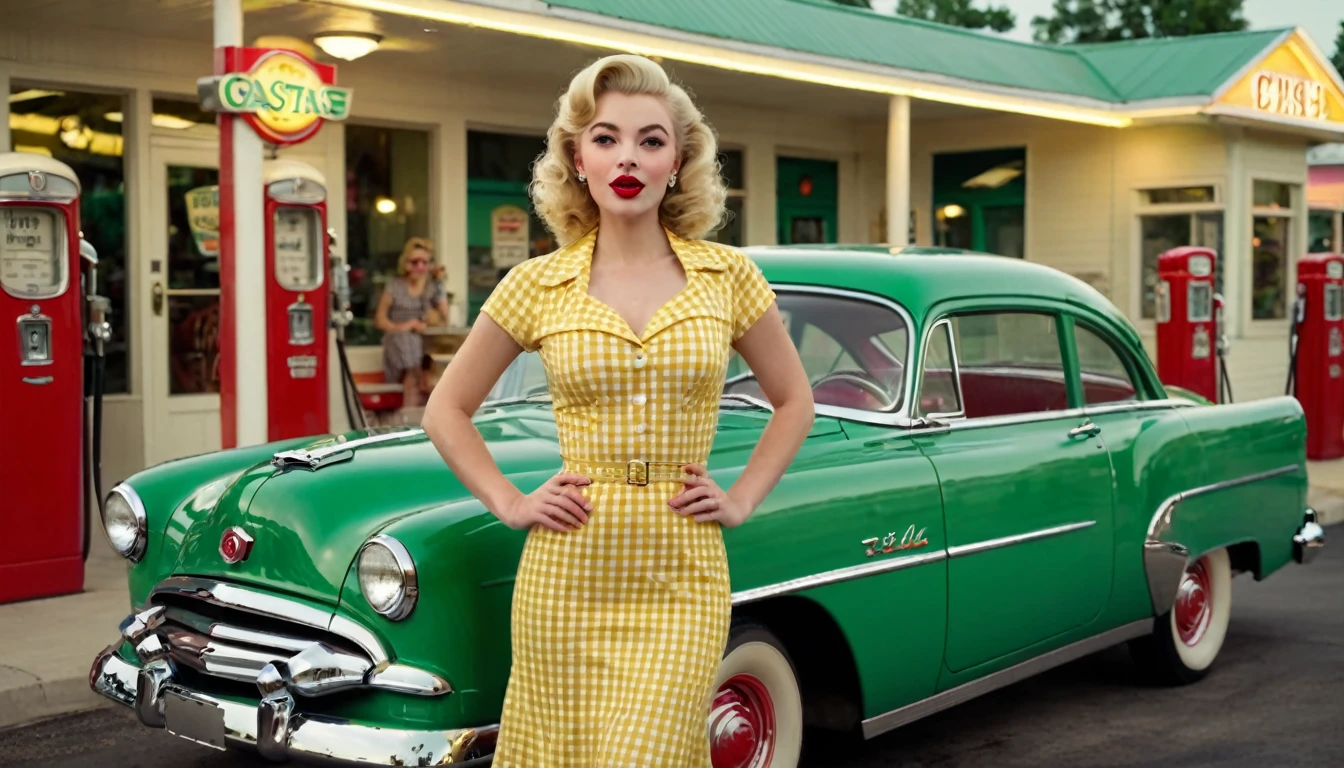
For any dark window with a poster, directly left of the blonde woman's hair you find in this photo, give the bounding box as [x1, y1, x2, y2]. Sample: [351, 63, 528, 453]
[467, 130, 559, 324]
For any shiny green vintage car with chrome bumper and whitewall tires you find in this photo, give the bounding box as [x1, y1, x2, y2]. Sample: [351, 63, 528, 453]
[90, 246, 1324, 768]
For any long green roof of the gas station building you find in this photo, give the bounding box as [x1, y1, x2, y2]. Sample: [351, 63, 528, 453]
[547, 0, 1288, 104]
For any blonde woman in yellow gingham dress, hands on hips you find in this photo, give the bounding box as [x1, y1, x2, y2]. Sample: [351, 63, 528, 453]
[423, 55, 813, 768]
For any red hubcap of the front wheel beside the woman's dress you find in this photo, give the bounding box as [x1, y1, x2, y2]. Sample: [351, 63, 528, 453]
[710, 674, 774, 768]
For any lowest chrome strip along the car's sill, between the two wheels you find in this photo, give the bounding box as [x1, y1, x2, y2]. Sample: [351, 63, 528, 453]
[863, 619, 1153, 738]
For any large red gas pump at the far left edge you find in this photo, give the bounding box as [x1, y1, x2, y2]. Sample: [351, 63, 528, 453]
[0, 152, 110, 603]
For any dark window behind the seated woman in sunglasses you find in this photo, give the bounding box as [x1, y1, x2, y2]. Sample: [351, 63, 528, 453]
[344, 125, 433, 344]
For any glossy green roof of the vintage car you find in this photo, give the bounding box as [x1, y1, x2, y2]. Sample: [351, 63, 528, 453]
[742, 243, 1133, 331]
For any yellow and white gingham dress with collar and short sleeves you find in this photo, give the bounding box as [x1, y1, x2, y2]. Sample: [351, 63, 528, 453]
[481, 230, 774, 768]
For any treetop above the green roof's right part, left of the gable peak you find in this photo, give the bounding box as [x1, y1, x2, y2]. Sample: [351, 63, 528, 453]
[1031, 0, 1249, 43]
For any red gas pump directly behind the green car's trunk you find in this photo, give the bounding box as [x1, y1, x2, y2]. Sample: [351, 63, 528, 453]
[1156, 246, 1232, 402]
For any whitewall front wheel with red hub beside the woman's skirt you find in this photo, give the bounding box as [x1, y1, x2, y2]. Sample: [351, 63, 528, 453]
[710, 621, 802, 768]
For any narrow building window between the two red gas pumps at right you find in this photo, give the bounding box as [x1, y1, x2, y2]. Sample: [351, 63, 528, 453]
[1251, 180, 1293, 320]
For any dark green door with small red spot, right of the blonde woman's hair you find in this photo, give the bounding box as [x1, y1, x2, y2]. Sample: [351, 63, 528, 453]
[775, 157, 840, 245]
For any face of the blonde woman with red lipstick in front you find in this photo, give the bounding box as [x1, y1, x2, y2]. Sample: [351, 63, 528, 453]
[574, 91, 680, 218]
